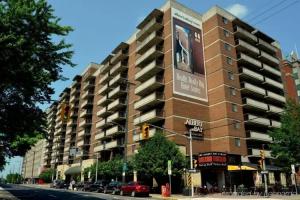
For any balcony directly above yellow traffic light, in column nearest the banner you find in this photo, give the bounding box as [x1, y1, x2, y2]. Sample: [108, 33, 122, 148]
[133, 109, 164, 125]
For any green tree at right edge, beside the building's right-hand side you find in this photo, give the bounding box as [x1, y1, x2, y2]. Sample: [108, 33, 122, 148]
[270, 101, 300, 171]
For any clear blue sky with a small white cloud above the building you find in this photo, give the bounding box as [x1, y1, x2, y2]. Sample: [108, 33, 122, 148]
[0, 0, 300, 177]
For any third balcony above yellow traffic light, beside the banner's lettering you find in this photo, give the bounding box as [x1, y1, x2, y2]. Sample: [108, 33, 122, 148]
[134, 76, 164, 96]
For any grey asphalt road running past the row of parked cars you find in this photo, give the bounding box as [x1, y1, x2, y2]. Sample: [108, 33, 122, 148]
[0, 185, 151, 200]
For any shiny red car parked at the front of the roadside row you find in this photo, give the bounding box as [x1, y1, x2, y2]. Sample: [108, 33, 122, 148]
[120, 182, 149, 197]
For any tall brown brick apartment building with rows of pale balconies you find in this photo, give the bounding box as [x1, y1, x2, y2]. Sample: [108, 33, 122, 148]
[46, 1, 286, 187]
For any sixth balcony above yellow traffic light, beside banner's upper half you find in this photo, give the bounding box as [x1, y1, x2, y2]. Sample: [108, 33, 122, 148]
[136, 31, 163, 54]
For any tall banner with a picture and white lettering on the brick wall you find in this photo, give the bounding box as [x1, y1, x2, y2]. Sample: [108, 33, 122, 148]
[172, 8, 207, 101]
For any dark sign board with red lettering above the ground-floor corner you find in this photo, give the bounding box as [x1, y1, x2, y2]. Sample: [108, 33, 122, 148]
[198, 152, 227, 167]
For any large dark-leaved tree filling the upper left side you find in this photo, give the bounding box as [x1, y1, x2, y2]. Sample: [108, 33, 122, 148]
[0, 0, 74, 169]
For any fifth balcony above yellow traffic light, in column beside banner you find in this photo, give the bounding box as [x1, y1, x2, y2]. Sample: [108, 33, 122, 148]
[135, 45, 164, 67]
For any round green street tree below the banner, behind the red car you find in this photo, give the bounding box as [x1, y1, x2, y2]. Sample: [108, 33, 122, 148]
[133, 133, 186, 188]
